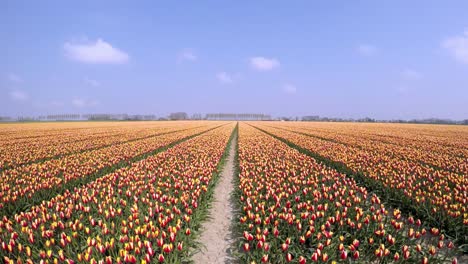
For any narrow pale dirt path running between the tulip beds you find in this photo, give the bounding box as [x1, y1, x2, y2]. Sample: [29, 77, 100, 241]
[193, 137, 237, 264]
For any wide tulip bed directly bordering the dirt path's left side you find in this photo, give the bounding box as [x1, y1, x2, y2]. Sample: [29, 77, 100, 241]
[0, 123, 234, 263]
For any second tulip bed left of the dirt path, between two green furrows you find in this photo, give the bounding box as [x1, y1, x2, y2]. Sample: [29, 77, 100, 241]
[0, 122, 222, 216]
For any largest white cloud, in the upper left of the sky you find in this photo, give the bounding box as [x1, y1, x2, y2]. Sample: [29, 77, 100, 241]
[63, 39, 130, 64]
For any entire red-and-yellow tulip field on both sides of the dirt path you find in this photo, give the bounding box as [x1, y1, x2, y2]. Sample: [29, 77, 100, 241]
[0, 121, 468, 264]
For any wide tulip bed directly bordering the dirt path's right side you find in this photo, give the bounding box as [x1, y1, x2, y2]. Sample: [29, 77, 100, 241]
[238, 124, 457, 264]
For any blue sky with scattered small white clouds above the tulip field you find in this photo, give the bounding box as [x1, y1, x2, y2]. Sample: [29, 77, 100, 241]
[0, 0, 468, 119]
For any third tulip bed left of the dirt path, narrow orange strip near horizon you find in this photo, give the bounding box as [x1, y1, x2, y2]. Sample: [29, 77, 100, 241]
[0, 123, 199, 170]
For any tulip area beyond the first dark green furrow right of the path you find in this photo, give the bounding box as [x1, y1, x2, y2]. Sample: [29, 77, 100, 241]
[252, 122, 468, 244]
